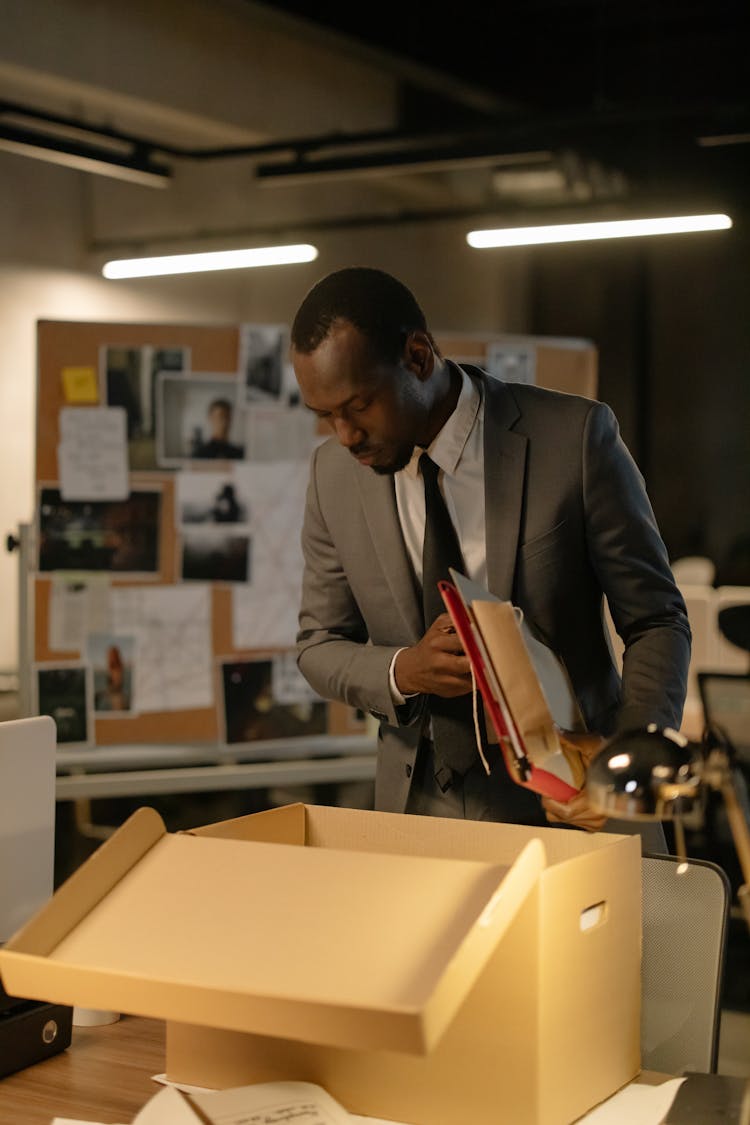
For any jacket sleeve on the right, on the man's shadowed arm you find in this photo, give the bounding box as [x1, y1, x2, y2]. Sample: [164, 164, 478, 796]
[582, 403, 692, 730]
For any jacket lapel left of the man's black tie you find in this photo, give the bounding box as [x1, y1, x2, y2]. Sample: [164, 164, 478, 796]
[356, 468, 424, 641]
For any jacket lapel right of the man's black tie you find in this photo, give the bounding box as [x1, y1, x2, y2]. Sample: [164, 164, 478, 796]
[474, 376, 528, 600]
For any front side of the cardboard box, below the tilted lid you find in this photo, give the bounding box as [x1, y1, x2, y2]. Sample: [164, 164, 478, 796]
[166, 887, 546, 1125]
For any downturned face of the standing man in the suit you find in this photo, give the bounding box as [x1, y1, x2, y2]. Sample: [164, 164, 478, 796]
[292, 322, 431, 474]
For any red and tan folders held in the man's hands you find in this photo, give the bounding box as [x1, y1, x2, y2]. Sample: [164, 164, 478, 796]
[440, 570, 586, 801]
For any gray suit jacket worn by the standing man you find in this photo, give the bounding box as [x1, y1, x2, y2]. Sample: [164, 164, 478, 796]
[298, 367, 690, 811]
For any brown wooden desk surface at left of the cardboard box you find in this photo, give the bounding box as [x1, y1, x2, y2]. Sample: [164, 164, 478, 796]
[0, 1016, 165, 1125]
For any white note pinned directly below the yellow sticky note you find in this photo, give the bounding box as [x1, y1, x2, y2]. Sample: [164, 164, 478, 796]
[57, 406, 130, 501]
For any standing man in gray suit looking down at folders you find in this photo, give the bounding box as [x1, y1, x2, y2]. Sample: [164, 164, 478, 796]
[291, 268, 690, 839]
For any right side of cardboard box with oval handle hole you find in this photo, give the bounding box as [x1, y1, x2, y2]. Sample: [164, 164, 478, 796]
[540, 837, 641, 1122]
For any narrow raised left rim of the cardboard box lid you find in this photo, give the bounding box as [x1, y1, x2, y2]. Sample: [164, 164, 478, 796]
[0, 808, 166, 958]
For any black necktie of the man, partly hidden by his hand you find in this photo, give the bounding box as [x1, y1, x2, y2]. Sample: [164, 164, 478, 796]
[419, 453, 478, 788]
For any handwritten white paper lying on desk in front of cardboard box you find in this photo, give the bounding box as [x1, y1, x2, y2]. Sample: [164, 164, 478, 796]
[187, 1082, 352, 1125]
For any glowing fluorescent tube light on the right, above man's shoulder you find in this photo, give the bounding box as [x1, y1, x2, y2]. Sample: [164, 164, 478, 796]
[467, 215, 732, 250]
